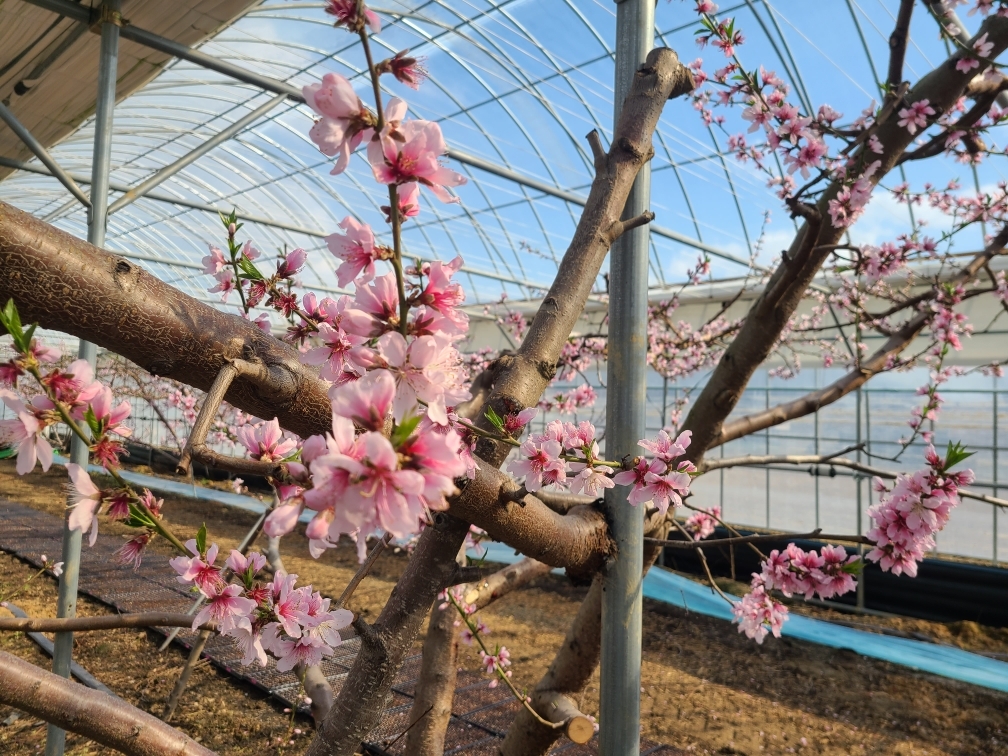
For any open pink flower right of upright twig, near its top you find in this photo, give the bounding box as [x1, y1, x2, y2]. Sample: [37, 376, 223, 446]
[368, 121, 466, 203]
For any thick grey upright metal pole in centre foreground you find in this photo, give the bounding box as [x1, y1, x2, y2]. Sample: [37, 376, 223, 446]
[599, 0, 654, 756]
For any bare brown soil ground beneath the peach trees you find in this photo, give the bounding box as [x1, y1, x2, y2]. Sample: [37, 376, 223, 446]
[0, 463, 1008, 756]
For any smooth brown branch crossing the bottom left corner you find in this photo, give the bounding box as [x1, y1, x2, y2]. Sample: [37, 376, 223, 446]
[0, 651, 214, 756]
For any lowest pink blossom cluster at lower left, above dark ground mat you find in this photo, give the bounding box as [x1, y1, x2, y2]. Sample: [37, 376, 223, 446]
[170, 540, 354, 672]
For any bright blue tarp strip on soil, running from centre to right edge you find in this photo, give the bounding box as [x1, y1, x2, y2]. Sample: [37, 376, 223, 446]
[471, 543, 1008, 692]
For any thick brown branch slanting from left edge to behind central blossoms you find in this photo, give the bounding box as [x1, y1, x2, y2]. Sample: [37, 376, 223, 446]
[0, 203, 332, 436]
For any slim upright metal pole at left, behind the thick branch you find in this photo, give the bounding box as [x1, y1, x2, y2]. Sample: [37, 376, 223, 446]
[45, 0, 122, 756]
